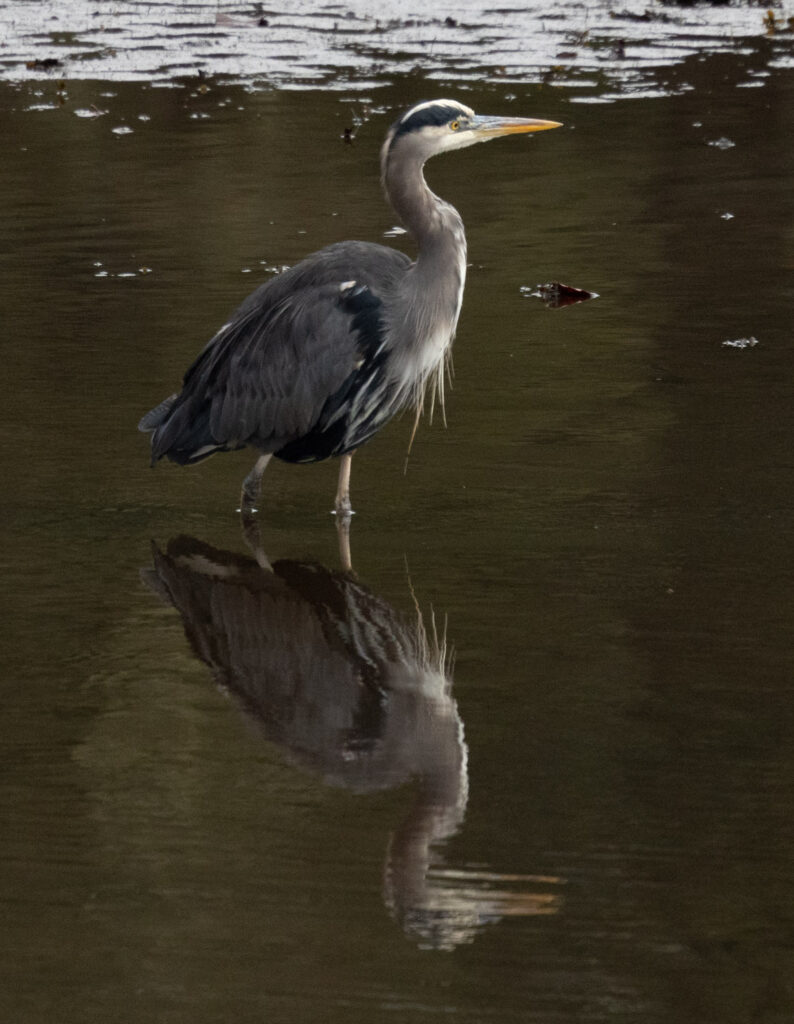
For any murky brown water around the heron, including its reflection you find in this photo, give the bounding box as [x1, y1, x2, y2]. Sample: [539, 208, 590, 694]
[0, 3, 794, 1024]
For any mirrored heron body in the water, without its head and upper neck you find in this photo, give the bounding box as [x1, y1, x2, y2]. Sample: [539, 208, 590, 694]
[149, 538, 465, 794]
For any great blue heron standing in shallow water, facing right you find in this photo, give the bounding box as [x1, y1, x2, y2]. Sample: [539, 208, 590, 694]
[138, 99, 559, 514]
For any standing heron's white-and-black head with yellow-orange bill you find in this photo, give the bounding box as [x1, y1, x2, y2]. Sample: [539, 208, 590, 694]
[381, 99, 560, 171]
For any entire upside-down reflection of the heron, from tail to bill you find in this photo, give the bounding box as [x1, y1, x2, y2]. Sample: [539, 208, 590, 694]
[144, 538, 558, 948]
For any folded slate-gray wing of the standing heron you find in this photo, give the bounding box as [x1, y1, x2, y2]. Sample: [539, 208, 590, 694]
[140, 242, 410, 463]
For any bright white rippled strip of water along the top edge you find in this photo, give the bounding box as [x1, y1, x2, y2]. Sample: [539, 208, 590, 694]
[6, 0, 794, 98]
